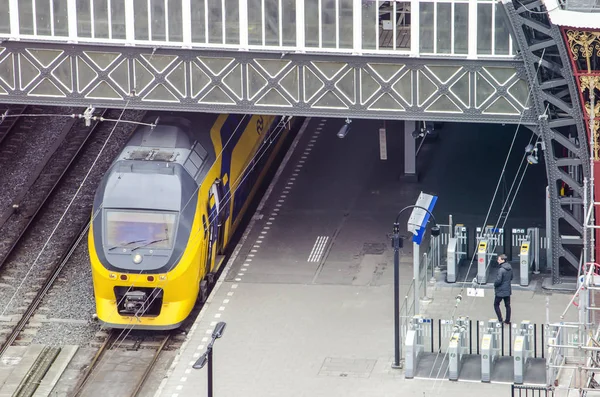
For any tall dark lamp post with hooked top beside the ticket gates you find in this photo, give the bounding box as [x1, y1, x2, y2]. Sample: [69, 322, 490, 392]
[392, 205, 440, 368]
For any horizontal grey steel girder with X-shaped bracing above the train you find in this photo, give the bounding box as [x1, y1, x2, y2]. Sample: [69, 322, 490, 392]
[0, 42, 535, 124]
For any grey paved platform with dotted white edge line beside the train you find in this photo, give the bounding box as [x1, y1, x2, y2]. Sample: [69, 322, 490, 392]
[155, 119, 572, 397]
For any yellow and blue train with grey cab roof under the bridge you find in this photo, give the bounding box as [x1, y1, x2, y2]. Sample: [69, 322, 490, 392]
[88, 114, 292, 330]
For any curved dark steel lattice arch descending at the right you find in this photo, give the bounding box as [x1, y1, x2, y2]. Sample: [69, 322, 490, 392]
[503, 0, 590, 284]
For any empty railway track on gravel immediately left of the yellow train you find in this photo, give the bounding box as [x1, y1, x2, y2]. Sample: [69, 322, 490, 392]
[0, 107, 143, 346]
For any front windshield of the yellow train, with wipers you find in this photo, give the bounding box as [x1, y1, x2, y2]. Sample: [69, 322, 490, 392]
[105, 210, 177, 249]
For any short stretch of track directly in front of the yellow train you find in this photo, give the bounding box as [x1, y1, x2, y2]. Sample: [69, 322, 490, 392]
[73, 330, 176, 397]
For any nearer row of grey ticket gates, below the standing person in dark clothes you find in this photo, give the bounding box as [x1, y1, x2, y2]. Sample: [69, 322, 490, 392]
[405, 316, 548, 384]
